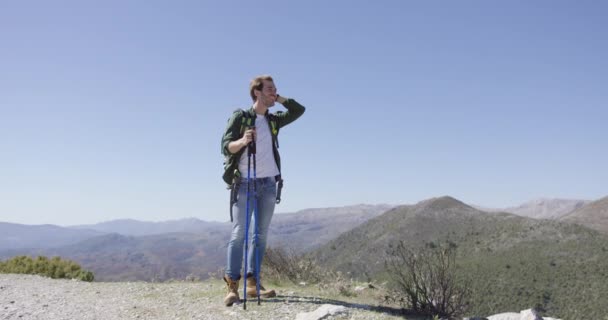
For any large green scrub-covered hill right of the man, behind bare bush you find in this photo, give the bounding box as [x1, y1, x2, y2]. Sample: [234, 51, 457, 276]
[312, 197, 608, 319]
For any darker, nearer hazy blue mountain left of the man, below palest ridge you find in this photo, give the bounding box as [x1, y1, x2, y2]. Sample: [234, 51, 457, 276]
[1, 231, 229, 281]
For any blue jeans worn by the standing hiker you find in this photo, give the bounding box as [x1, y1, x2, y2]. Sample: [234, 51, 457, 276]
[226, 177, 277, 280]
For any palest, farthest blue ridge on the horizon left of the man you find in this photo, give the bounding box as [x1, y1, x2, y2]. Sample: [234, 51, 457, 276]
[70, 218, 226, 236]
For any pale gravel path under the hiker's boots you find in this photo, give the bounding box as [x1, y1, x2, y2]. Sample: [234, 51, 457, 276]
[0, 274, 402, 320]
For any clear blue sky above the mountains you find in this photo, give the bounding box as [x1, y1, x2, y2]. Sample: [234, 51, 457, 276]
[0, 1, 608, 225]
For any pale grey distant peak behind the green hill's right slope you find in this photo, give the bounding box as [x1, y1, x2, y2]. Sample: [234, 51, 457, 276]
[501, 198, 591, 219]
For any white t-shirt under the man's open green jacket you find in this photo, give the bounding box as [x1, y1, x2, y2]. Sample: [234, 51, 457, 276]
[239, 114, 279, 179]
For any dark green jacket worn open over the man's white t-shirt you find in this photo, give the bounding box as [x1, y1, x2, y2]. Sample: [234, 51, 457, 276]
[222, 99, 305, 185]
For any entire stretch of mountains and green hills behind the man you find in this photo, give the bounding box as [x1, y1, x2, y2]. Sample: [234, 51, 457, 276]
[0, 196, 608, 319]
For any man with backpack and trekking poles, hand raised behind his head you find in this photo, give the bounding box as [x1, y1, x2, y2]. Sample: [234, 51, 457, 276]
[222, 75, 304, 306]
